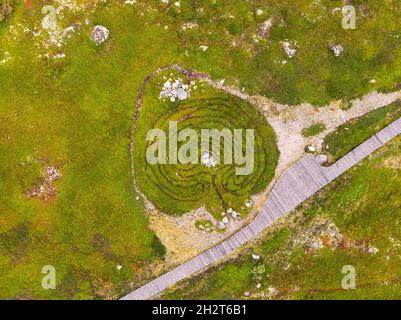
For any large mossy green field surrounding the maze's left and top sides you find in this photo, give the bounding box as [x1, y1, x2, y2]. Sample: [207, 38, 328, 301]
[0, 0, 401, 299]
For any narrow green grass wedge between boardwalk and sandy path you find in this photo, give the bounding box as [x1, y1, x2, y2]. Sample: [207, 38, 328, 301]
[323, 100, 401, 163]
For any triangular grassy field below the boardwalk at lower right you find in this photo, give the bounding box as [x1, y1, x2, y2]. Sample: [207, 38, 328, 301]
[164, 107, 401, 299]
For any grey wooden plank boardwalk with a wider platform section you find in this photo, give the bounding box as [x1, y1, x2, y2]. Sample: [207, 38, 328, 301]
[122, 118, 401, 300]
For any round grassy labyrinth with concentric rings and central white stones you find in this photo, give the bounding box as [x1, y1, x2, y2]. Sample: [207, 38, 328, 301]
[134, 71, 279, 220]
